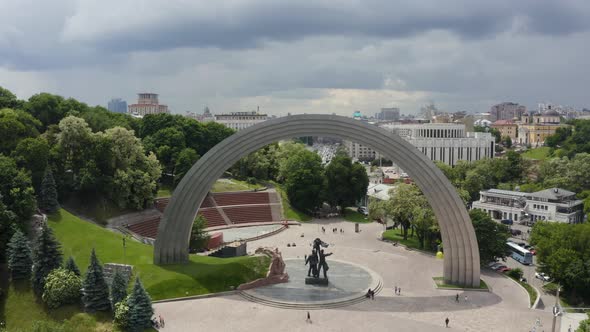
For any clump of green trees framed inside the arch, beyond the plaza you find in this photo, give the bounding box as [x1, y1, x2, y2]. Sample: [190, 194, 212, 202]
[230, 142, 369, 217]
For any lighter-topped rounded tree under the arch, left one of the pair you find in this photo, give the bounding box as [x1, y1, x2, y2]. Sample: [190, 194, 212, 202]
[280, 148, 324, 211]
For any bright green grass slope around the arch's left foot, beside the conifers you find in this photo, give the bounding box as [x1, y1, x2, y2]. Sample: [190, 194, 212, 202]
[49, 209, 268, 300]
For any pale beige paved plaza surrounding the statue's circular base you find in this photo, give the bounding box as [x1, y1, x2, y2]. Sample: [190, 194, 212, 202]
[154, 219, 552, 331]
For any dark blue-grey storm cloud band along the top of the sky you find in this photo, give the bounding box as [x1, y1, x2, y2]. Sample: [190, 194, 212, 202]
[63, 0, 590, 52]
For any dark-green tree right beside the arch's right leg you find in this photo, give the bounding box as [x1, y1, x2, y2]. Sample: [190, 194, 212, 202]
[469, 209, 509, 265]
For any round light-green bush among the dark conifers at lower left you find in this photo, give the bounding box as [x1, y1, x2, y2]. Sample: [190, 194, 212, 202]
[42, 268, 82, 309]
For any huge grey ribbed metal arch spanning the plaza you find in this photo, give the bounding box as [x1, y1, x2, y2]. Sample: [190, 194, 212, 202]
[154, 114, 480, 287]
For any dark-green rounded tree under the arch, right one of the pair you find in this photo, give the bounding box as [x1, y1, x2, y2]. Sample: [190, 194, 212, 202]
[326, 152, 369, 213]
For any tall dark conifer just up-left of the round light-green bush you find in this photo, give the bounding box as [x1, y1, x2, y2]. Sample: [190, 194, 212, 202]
[31, 225, 62, 295]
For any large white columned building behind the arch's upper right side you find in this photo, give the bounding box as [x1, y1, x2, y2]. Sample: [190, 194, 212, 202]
[345, 123, 494, 166]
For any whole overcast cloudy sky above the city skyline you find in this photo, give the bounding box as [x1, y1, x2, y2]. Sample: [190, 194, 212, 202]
[0, 0, 590, 115]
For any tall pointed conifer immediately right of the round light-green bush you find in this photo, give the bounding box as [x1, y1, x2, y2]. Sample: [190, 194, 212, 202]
[82, 248, 111, 311]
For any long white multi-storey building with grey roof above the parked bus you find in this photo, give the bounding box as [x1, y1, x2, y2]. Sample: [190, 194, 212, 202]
[471, 188, 584, 224]
